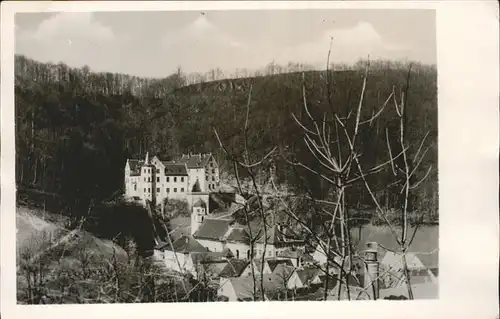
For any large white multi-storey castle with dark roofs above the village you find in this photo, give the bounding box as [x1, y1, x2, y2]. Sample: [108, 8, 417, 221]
[125, 153, 220, 233]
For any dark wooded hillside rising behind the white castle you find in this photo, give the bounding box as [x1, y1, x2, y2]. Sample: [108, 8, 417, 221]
[15, 56, 437, 225]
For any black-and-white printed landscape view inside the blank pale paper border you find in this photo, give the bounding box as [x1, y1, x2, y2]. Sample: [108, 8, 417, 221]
[2, 0, 500, 318]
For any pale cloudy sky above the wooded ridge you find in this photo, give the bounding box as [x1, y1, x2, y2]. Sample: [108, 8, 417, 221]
[15, 9, 436, 77]
